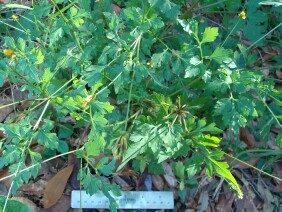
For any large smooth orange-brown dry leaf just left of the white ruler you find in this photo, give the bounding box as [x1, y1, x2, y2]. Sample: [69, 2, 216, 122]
[43, 165, 73, 208]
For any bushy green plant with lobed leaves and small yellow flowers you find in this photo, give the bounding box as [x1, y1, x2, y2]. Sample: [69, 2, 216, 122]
[0, 0, 281, 211]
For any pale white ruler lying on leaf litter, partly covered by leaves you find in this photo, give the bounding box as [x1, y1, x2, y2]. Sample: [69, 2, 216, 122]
[71, 190, 174, 209]
